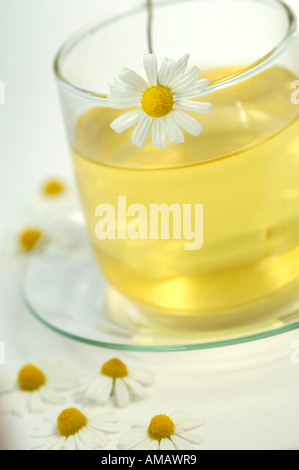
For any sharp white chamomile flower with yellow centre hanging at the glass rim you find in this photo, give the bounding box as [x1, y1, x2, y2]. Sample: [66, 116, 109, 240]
[107, 54, 213, 148]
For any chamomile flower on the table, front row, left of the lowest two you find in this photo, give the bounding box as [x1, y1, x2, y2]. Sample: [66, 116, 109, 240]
[31, 408, 122, 450]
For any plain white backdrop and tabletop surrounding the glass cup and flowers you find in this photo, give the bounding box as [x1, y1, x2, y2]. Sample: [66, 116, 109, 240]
[0, 0, 299, 449]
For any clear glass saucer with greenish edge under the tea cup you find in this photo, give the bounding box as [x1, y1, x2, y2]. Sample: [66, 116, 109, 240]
[22, 243, 299, 351]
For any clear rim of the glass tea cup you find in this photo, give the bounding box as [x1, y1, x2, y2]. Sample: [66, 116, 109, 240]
[54, 0, 297, 104]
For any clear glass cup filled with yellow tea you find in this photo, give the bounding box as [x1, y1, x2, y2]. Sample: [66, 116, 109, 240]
[55, 0, 299, 331]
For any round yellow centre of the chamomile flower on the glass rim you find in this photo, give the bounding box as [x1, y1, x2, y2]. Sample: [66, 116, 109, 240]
[141, 85, 174, 118]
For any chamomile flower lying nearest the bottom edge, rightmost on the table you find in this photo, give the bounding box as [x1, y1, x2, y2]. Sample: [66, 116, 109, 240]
[119, 411, 205, 450]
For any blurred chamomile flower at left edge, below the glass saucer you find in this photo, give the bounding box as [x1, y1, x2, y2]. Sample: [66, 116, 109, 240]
[0, 361, 78, 416]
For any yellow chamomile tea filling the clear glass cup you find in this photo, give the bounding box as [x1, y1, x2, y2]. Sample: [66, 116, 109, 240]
[72, 67, 299, 322]
